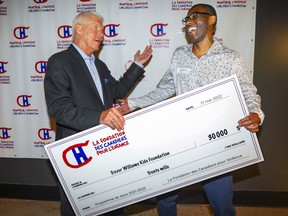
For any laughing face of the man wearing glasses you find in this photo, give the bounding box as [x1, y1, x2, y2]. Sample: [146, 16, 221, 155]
[185, 6, 215, 44]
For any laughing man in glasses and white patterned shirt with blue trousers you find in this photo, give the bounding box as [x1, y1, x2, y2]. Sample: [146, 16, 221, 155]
[123, 4, 264, 216]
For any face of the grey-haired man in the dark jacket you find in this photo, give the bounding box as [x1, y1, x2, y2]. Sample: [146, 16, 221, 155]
[74, 15, 104, 56]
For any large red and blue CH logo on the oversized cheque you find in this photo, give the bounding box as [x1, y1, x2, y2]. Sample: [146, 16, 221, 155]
[62, 140, 92, 169]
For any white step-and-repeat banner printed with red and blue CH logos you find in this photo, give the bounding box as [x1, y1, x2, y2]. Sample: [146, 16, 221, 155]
[0, 0, 256, 158]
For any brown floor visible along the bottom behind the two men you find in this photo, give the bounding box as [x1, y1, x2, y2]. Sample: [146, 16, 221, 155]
[0, 198, 288, 216]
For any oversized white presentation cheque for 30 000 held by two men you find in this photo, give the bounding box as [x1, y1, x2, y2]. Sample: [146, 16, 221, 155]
[45, 76, 263, 215]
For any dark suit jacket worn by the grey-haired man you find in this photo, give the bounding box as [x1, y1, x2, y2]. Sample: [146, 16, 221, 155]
[44, 45, 144, 140]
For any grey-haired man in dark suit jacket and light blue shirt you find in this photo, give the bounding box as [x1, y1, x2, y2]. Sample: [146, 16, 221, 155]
[44, 11, 152, 216]
